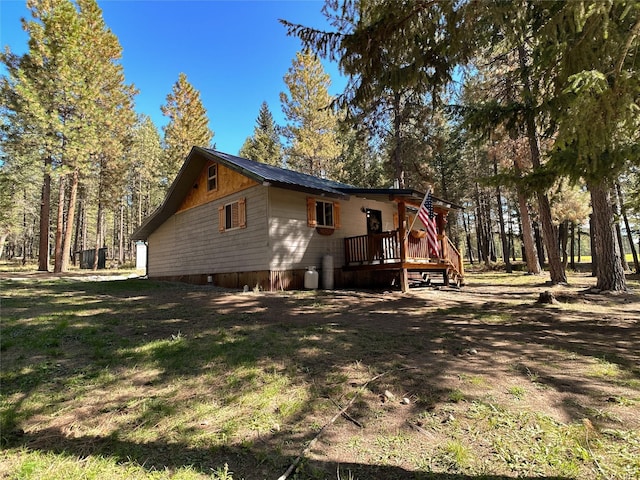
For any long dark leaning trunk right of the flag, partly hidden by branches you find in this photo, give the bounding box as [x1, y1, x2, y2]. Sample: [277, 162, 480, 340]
[518, 43, 567, 283]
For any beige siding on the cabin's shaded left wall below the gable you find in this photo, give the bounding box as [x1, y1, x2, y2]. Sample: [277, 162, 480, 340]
[148, 186, 269, 277]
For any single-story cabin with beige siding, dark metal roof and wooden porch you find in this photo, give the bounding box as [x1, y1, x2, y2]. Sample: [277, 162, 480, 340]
[133, 147, 464, 291]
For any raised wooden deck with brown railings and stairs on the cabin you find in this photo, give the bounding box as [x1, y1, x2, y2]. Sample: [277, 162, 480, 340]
[343, 230, 464, 285]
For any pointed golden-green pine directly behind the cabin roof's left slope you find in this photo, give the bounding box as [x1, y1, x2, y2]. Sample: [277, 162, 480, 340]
[161, 73, 214, 185]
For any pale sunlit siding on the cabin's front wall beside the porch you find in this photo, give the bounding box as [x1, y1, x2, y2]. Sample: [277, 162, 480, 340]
[269, 188, 397, 270]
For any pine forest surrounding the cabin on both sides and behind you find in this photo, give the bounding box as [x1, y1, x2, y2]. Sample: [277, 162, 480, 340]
[0, 0, 640, 290]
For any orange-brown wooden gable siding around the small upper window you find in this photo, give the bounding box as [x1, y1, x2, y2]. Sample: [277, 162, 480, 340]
[178, 162, 258, 212]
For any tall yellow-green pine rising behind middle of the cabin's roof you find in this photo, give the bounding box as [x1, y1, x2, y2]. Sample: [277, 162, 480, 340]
[280, 51, 340, 178]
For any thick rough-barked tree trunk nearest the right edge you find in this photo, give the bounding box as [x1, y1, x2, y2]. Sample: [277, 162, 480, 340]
[589, 181, 627, 292]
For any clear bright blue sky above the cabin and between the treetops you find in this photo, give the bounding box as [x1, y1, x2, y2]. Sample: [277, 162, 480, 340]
[0, 0, 345, 154]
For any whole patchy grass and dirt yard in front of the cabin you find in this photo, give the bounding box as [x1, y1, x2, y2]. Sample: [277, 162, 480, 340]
[0, 272, 640, 480]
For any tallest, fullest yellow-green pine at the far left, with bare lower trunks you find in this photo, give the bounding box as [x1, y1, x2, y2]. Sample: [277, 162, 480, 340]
[3, 0, 133, 272]
